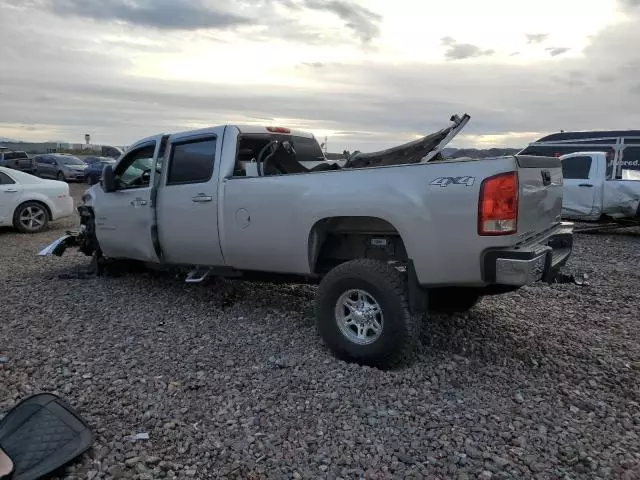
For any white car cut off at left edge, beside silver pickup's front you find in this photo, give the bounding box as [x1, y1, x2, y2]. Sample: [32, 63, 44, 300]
[0, 167, 73, 233]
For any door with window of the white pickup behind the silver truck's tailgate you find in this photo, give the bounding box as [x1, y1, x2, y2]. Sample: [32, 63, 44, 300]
[562, 155, 604, 220]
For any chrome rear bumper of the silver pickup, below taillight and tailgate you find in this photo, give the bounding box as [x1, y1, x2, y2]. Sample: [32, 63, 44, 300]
[482, 222, 573, 286]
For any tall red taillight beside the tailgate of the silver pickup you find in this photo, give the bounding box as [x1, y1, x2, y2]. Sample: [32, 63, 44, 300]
[478, 172, 518, 235]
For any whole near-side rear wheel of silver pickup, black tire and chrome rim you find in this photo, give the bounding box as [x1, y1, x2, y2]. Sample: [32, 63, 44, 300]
[316, 259, 421, 368]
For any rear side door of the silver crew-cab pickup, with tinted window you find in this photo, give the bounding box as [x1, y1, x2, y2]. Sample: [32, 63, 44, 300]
[157, 128, 224, 266]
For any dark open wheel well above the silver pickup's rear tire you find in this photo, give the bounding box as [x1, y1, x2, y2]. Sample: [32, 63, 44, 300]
[309, 217, 408, 274]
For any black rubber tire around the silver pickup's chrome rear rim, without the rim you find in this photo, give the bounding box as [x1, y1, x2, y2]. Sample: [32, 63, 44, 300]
[316, 259, 422, 368]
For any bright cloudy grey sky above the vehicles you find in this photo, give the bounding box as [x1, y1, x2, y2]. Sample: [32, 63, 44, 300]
[0, 0, 640, 151]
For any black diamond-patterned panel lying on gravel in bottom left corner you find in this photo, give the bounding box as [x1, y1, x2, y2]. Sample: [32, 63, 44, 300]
[0, 393, 95, 480]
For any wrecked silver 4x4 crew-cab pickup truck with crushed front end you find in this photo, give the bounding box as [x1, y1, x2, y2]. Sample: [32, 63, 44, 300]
[40, 115, 573, 368]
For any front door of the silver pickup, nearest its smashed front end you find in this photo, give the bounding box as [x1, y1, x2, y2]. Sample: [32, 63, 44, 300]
[95, 135, 162, 263]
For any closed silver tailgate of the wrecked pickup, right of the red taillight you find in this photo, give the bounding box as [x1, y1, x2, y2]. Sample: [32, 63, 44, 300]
[515, 155, 562, 239]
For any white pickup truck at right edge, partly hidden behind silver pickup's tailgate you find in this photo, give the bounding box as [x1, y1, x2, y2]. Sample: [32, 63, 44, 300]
[560, 151, 640, 221]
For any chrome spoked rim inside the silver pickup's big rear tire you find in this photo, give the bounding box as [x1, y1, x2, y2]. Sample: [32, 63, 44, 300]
[335, 289, 384, 345]
